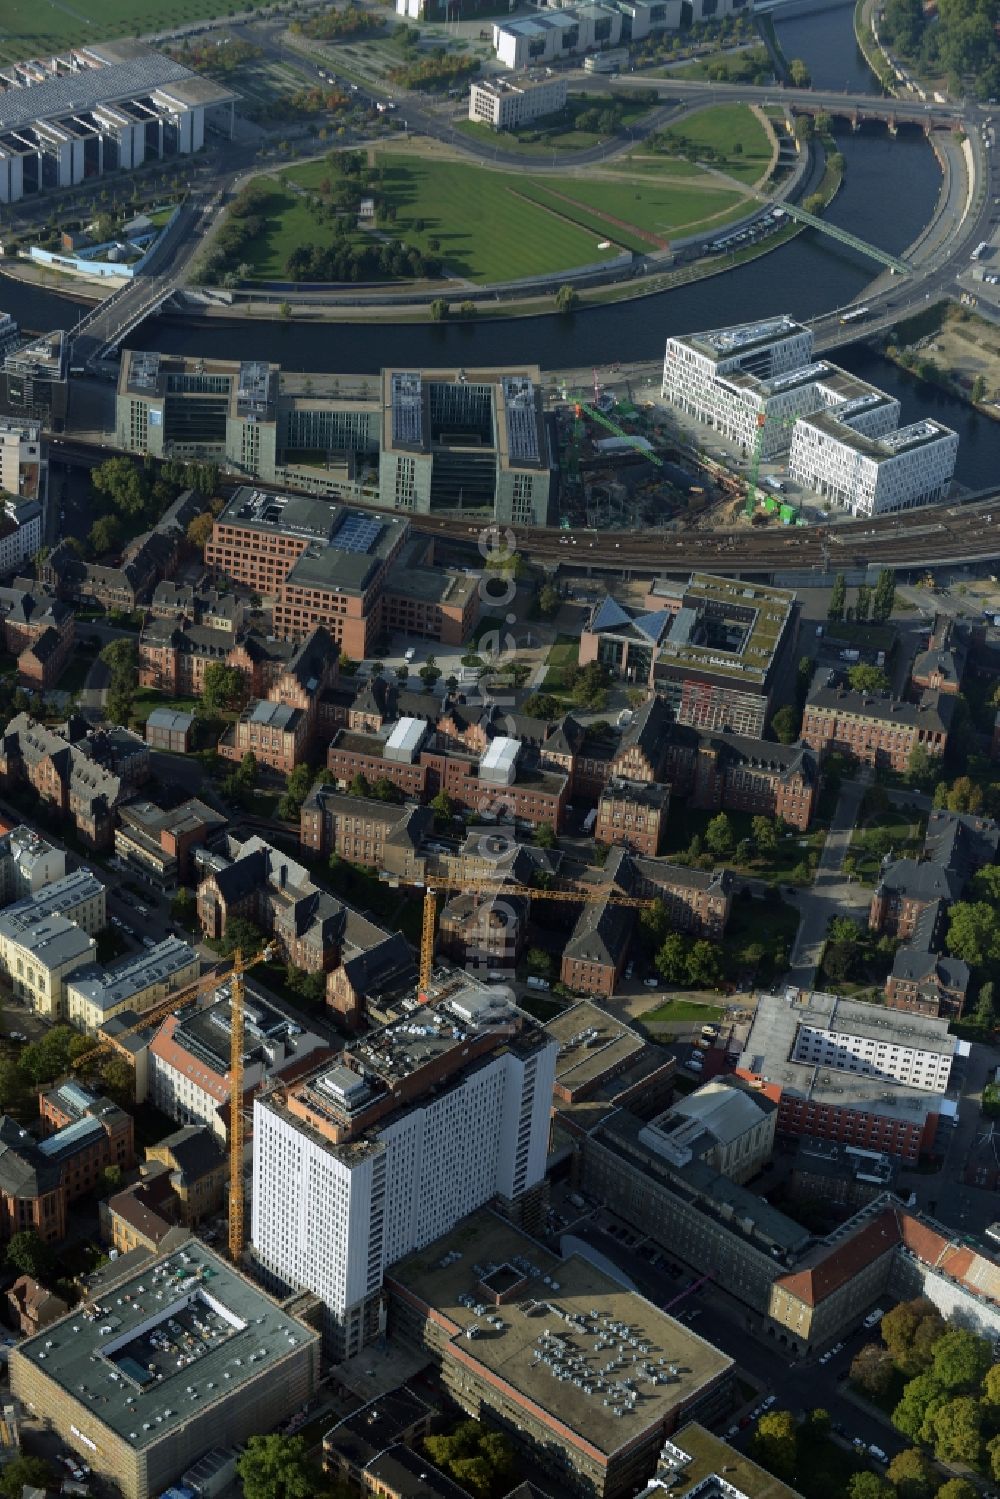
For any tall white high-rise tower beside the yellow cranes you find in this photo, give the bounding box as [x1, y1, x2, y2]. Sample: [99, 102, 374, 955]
[252, 985, 558, 1358]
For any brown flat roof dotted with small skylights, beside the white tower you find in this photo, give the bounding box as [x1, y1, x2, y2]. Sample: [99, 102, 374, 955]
[385, 1211, 733, 1459]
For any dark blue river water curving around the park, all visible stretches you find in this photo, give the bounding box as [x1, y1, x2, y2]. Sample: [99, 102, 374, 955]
[0, 4, 1000, 489]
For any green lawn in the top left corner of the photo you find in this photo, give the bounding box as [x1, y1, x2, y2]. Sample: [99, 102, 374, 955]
[0, 0, 246, 61]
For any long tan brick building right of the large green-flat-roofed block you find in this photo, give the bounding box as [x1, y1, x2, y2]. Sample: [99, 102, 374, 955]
[801, 672, 955, 772]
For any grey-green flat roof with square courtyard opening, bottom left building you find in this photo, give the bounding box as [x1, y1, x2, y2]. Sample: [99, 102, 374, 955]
[10, 1238, 318, 1450]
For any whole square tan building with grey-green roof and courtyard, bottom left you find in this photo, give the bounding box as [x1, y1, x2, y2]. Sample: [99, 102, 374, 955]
[10, 1238, 319, 1499]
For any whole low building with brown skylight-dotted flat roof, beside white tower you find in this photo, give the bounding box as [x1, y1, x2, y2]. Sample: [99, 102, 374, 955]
[387, 1213, 733, 1499]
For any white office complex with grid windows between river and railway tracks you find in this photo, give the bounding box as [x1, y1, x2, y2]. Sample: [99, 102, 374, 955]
[663, 316, 958, 516]
